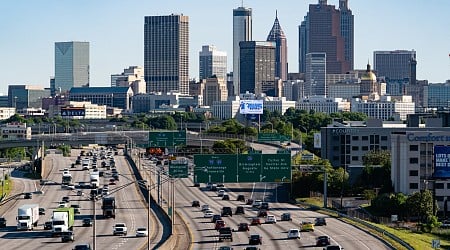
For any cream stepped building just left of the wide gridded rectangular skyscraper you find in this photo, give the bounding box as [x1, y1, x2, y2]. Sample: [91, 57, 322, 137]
[111, 66, 146, 95]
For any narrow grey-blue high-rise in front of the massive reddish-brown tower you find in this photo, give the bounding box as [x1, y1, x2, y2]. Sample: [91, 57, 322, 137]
[305, 53, 327, 97]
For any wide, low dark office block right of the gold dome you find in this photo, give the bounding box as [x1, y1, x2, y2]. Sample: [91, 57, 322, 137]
[373, 50, 417, 82]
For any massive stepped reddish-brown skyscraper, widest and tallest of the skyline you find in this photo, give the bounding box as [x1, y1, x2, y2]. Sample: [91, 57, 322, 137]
[299, 0, 354, 74]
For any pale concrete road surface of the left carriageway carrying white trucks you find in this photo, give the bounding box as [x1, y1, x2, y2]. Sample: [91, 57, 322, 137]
[0, 149, 151, 249]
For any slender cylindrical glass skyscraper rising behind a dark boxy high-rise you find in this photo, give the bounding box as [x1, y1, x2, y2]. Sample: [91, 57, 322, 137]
[233, 7, 252, 95]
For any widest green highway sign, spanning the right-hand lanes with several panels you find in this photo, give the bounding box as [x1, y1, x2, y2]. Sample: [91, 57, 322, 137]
[194, 154, 291, 183]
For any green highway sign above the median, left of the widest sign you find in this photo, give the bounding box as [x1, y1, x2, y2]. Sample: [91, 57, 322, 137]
[148, 130, 186, 147]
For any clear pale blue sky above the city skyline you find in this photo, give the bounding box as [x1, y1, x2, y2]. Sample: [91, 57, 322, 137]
[0, 0, 450, 94]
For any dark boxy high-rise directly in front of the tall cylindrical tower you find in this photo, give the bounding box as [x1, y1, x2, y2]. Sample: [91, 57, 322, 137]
[239, 41, 276, 94]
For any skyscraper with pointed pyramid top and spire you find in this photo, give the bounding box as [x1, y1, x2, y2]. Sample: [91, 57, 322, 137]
[267, 11, 288, 81]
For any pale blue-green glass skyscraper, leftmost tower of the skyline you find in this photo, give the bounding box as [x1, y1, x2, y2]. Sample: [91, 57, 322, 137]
[51, 42, 89, 93]
